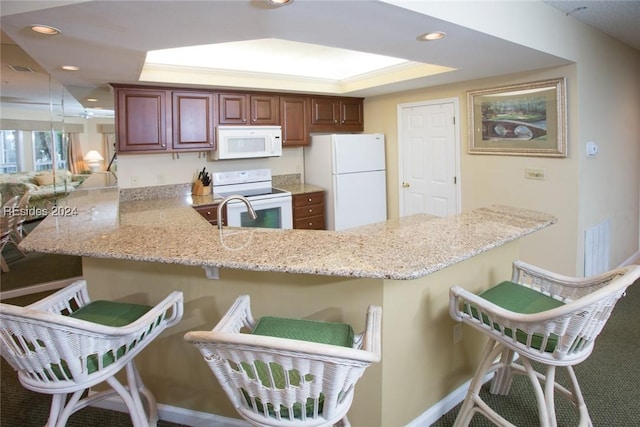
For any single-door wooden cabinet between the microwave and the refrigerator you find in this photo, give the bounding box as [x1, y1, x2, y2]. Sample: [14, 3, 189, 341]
[280, 96, 311, 147]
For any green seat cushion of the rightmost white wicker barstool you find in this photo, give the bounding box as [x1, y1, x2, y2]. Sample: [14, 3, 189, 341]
[472, 281, 564, 352]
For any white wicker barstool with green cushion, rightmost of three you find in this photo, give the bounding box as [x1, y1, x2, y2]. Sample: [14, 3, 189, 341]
[450, 261, 640, 426]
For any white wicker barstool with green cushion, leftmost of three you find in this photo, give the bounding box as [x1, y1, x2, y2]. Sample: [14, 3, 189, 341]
[0, 280, 183, 427]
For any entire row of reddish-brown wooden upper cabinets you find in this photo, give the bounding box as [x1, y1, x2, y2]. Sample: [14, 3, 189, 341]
[111, 83, 364, 154]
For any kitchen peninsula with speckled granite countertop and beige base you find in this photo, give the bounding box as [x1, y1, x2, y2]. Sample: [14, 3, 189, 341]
[21, 172, 556, 426]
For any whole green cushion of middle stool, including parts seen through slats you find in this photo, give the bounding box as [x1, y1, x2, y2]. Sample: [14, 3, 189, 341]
[241, 316, 354, 419]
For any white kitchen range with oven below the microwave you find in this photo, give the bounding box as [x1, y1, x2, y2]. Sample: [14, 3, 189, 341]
[211, 169, 293, 228]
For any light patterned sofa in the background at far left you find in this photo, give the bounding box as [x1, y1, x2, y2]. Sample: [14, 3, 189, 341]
[0, 170, 89, 221]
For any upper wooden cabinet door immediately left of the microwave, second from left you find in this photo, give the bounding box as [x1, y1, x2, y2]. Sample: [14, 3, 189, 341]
[172, 91, 215, 150]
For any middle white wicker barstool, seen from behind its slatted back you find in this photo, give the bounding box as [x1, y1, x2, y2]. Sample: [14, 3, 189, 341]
[185, 295, 382, 427]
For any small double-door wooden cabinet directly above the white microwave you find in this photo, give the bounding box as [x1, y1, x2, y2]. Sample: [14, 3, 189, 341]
[218, 93, 280, 126]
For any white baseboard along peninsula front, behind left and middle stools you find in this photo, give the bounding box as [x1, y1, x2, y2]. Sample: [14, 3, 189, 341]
[93, 396, 251, 427]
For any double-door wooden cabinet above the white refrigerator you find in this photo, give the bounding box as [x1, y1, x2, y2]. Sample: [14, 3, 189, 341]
[311, 96, 364, 132]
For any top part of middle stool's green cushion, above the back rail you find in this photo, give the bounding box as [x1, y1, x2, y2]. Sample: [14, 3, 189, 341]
[253, 316, 353, 347]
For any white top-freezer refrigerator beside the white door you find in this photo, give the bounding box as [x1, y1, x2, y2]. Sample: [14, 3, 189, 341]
[304, 133, 387, 230]
